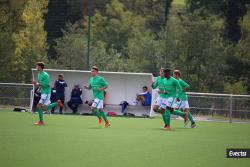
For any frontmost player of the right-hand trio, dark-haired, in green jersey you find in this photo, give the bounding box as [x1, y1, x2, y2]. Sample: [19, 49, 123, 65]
[164, 69, 187, 130]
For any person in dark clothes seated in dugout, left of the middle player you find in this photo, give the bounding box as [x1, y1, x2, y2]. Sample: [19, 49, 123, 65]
[68, 85, 82, 114]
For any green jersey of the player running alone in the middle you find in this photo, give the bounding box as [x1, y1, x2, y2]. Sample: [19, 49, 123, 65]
[89, 76, 108, 100]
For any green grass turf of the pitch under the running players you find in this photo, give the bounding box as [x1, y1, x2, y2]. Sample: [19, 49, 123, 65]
[0, 111, 250, 167]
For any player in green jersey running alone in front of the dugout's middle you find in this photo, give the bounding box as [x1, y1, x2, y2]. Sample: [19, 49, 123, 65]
[84, 66, 110, 128]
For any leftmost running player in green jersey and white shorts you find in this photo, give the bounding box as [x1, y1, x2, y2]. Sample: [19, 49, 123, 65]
[32, 62, 63, 125]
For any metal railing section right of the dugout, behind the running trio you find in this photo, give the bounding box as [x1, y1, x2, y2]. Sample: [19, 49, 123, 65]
[188, 92, 250, 122]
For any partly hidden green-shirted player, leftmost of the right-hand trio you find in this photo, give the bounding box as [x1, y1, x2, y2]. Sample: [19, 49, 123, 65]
[152, 68, 167, 126]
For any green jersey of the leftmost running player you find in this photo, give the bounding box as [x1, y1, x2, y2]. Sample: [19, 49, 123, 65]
[38, 71, 50, 94]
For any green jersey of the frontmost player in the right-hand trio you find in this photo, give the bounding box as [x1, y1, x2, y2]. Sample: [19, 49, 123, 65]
[164, 77, 182, 98]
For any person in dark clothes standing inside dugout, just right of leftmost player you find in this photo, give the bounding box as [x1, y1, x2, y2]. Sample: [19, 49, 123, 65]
[54, 74, 68, 114]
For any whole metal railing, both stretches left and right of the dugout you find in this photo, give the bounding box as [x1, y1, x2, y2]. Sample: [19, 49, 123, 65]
[0, 83, 250, 122]
